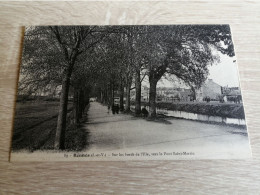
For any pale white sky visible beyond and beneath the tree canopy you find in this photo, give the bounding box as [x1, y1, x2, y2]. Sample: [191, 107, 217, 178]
[143, 52, 239, 88]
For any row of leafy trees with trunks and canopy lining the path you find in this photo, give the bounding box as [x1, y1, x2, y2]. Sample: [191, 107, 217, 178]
[19, 25, 234, 149]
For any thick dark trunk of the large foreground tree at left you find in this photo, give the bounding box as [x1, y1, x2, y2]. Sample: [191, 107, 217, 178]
[54, 74, 70, 150]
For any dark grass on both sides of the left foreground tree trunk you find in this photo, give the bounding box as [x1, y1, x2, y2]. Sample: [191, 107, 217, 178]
[12, 100, 86, 152]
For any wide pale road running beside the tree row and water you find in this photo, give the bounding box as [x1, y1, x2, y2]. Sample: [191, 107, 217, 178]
[84, 102, 250, 158]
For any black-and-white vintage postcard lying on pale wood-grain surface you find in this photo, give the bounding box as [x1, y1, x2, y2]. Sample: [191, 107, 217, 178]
[11, 25, 251, 161]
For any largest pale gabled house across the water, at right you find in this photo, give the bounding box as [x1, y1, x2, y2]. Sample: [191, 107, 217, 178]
[196, 79, 222, 101]
